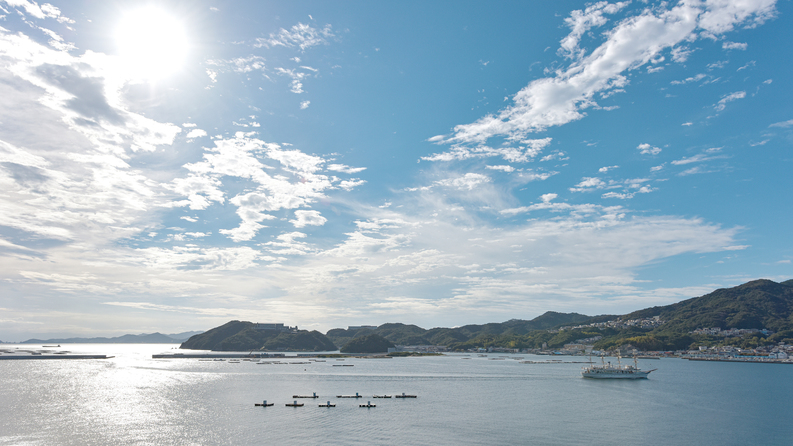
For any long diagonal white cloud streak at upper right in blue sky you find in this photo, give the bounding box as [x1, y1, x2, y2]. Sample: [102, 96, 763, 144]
[433, 0, 775, 145]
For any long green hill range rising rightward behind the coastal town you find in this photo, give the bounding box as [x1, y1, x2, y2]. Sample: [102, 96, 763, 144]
[328, 280, 793, 350]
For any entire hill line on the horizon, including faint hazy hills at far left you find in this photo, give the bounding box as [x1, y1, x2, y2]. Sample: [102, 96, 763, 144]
[13, 279, 793, 351]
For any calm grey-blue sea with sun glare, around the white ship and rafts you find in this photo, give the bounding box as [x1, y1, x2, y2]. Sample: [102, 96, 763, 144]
[0, 344, 793, 445]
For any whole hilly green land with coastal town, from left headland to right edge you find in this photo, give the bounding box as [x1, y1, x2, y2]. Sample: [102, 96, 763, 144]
[181, 279, 793, 353]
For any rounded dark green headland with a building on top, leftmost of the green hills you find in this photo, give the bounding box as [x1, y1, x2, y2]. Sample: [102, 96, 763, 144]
[180, 321, 336, 352]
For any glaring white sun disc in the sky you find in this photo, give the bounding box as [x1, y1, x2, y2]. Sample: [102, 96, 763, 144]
[115, 6, 188, 79]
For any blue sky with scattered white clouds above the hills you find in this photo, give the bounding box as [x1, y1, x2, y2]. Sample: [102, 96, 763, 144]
[0, 0, 793, 342]
